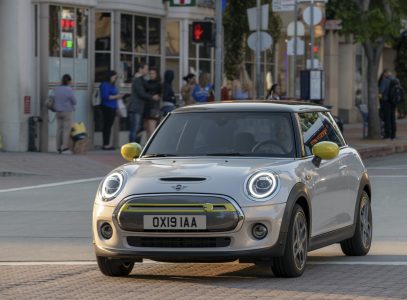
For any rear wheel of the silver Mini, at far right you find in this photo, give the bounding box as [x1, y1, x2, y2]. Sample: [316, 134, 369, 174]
[341, 191, 373, 256]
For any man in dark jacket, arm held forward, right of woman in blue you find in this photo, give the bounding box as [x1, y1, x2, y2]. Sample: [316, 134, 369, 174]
[127, 63, 160, 143]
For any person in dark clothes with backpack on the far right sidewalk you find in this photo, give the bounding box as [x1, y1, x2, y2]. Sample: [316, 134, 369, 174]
[379, 69, 404, 140]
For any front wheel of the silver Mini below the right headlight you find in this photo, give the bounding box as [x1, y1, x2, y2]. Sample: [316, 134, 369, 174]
[271, 204, 308, 277]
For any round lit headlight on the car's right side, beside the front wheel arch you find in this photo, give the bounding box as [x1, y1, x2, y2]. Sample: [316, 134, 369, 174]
[246, 172, 278, 200]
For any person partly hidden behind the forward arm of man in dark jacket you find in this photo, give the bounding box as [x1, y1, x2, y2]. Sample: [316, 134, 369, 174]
[143, 67, 162, 140]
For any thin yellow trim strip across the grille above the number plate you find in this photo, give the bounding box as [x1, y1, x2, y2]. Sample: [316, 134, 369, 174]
[121, 203, 236, 213]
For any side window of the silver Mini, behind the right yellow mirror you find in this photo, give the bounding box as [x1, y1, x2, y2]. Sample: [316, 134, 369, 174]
[298, 112, 345, 156]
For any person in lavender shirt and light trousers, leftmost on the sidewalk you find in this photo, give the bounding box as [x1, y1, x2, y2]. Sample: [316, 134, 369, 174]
[51, 74, 76, 154]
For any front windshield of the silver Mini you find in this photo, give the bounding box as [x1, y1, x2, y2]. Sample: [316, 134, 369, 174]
[143, 112, 295, 158]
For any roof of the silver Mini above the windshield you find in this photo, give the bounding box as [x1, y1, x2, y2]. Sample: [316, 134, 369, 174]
[173, 100, 329, 113]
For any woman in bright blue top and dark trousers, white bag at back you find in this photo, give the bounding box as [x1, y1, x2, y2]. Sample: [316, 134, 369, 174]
[99, 70, 124, 150]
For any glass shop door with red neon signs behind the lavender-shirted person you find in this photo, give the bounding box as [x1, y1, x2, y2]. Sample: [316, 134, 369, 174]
[48, 5, 90, 151]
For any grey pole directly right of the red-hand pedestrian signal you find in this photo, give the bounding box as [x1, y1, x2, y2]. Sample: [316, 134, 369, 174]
[215, 0, 223, 101]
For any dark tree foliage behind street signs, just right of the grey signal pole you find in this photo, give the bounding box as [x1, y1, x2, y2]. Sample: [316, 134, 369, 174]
[223, 0, 281, 80]
